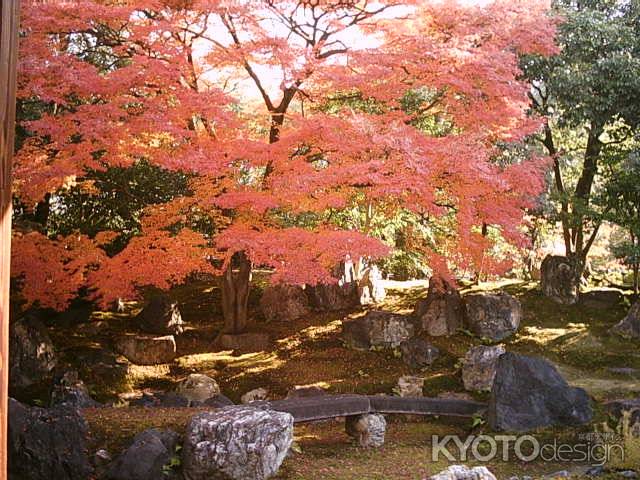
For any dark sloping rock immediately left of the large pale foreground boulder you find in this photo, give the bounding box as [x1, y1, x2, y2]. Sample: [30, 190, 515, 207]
[105, 428, 178, 480]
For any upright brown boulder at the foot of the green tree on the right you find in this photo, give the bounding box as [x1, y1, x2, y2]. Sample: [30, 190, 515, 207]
[540, 255, 583, 305]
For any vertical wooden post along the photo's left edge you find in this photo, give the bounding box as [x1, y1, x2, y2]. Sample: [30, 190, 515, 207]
[0, 0, 19, 480]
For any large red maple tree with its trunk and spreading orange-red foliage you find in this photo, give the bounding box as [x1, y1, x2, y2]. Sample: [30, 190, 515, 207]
[13, 0, 554, 332]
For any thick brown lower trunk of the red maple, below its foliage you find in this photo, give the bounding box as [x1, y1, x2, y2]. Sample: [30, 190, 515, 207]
[222, 252, 251, 334]
